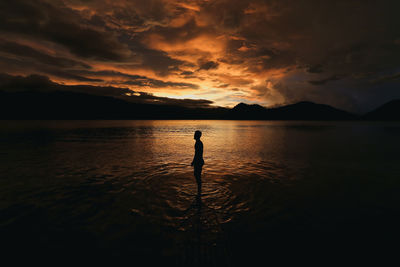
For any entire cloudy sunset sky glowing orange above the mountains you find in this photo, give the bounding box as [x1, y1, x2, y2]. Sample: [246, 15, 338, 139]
[0, 0, 400, 113]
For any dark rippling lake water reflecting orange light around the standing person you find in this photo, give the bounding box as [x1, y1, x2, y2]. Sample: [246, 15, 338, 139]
[0, 121, 400, 266]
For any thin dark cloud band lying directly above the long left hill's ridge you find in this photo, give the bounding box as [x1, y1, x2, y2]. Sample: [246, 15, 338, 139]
[0, 73, 213, 108]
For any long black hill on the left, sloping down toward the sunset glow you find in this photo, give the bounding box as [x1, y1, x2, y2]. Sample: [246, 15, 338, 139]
[0, 91, 227, 119]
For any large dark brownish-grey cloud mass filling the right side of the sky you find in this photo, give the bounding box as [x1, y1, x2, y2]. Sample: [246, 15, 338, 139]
[209, 0, 400, 110]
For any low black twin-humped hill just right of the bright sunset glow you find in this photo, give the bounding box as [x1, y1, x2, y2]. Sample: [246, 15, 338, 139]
[229, 102, 357, 120]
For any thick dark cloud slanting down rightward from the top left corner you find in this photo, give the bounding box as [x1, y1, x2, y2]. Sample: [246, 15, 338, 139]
[0, 0, 128, 60]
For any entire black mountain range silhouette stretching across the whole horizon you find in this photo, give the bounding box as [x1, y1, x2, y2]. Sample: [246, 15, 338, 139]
[0, 91, 400, 120]
